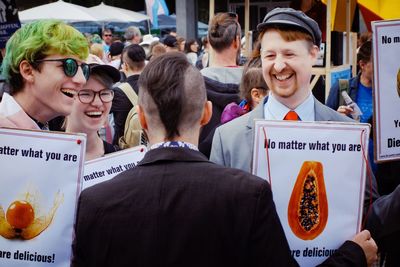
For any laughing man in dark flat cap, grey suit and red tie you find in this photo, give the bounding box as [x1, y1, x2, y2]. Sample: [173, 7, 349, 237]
[210, 8, 377, 266]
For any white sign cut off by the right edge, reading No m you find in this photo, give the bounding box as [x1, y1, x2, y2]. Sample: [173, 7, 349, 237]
[372, 20, 400, 162]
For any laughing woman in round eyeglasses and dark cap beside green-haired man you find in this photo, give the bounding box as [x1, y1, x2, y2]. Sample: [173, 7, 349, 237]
[65, 64, 120, 160]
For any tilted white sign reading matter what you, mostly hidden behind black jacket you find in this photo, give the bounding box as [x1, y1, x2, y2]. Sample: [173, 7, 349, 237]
[82, 146, 147, 190]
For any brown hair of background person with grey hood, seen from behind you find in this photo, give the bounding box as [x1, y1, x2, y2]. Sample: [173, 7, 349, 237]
[208, 13, 241, 52]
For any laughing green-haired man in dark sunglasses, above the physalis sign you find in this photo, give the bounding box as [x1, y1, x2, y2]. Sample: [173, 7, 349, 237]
[0, 20, 89, 129]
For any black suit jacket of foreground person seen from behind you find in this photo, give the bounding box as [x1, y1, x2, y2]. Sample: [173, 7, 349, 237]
[73, 148, 297, 267]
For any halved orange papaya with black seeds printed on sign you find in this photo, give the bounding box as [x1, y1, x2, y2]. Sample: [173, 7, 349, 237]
[288, 161, 328, 240]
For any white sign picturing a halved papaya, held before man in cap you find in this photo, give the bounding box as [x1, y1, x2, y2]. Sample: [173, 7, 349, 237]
[253, 120, 369, 266]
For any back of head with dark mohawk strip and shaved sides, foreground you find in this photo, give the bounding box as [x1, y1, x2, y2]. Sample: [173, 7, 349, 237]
[139, 52, 207, 140]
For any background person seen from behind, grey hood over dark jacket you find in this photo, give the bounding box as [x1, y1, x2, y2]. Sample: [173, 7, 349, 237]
[199, 12, 243, 157]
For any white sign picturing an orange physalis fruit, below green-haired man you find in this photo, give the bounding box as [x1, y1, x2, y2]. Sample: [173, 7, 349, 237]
[0, 129, 86, 267]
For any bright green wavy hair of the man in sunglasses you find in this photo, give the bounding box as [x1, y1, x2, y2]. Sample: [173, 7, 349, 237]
[1, 20, 89, 94]
